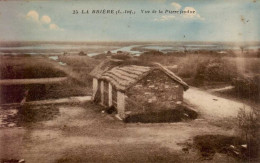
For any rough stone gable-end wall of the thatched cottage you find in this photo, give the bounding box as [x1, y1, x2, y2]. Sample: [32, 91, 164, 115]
[126, 70, 183, 112]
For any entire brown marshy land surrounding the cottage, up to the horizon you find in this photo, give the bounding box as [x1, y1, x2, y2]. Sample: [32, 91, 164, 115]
[0, 42, 260, 163]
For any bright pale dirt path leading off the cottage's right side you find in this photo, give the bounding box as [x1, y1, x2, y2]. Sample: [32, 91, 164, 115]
[184, 87, 250, 119]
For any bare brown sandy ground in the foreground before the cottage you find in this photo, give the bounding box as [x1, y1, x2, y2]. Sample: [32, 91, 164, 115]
[0, 101, 238, 163]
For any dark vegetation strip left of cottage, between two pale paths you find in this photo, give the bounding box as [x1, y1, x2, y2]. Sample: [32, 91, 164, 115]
[0, 80, 88, 104]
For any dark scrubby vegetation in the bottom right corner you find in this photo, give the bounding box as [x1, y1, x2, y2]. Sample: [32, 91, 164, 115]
[193, 108, 260, 161]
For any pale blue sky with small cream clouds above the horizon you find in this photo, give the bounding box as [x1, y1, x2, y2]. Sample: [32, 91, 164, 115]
[0, 0, 260, 41]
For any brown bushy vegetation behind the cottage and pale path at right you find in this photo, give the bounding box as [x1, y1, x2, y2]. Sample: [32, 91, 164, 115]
[139, 51, 260, 102]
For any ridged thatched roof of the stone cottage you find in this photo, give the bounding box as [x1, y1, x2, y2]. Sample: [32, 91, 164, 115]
[90, 61, 189, 91]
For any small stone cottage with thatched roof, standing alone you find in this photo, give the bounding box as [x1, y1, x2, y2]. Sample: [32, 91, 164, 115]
[90, 60, 189, 119]
